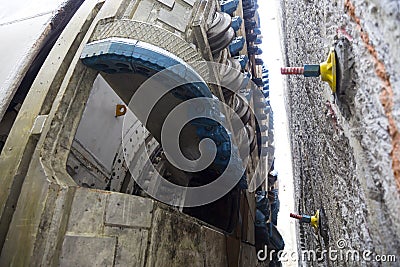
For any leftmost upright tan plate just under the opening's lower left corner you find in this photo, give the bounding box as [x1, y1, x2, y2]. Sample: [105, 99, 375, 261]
[67, 188, 109, 234]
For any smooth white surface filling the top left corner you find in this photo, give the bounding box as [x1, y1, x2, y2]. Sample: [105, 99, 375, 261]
[0, 0, 65, 119]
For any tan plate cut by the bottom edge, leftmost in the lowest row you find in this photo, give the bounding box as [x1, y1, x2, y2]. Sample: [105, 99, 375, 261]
[60, 235, 116, 267]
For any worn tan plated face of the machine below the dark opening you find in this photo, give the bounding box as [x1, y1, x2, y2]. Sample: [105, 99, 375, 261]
[59, 188, 256, 266]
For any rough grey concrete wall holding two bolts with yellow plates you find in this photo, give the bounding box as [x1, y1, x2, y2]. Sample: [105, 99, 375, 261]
[281, 0, 400, 266]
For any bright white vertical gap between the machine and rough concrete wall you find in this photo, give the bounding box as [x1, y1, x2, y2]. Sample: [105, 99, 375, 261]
[258, 0, 298, 266]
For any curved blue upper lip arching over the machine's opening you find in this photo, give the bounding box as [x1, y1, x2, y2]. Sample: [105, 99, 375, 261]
[81, 38, 212, 99]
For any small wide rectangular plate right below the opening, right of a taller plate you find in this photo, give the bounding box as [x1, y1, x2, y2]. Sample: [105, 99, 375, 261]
[105, 193, 153, 228]
